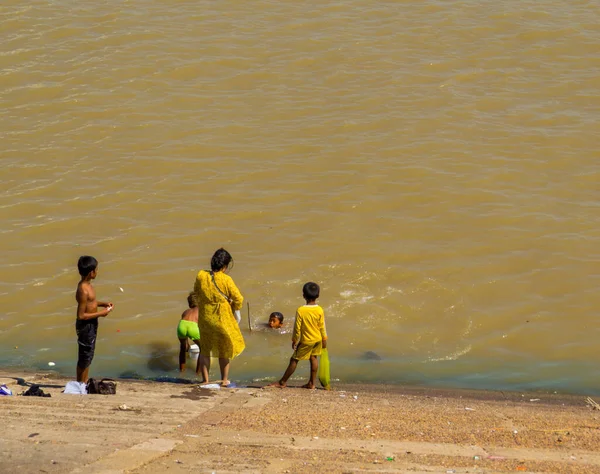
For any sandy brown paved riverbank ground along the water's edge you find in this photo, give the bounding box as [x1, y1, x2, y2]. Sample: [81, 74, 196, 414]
[0, 373, 600, 474]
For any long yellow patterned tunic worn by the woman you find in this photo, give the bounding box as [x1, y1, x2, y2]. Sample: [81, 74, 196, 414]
[194, 270, 246, 359]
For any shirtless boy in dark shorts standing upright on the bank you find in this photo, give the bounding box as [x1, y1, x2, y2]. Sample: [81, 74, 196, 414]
[75, 255, 114, 383]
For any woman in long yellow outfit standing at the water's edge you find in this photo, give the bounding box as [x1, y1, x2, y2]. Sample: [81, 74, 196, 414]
[194, 248, 246, 387]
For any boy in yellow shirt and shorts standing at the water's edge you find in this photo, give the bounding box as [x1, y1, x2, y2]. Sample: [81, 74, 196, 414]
[270, 281, 327, 389]
